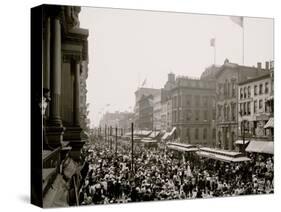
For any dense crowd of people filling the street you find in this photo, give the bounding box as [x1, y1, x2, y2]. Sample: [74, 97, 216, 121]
[77, 137, 274, 205]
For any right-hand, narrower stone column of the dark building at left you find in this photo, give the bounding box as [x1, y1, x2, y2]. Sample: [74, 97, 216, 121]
[73, 61, 80, 126]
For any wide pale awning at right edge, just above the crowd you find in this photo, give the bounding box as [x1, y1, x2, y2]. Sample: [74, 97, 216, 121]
[246, 141, 274, 155]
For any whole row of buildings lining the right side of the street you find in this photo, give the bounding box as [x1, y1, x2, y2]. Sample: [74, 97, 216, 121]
[130, 59, 274, 151]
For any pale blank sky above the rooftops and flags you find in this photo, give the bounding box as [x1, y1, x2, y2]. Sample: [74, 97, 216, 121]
[79, 7, 274, 126]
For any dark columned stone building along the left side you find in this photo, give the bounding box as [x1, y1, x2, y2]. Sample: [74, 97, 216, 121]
[31, 5, 88, 207]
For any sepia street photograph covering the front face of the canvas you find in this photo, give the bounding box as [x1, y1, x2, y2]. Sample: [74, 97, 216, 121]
[41, 5, 274, 207]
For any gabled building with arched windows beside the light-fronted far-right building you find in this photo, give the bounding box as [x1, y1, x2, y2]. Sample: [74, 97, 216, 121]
[211, 59, 268, 150]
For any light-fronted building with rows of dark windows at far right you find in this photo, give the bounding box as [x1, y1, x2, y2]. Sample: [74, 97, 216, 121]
[238, 62, 274, 144]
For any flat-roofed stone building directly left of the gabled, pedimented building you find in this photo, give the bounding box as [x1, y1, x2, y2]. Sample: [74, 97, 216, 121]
[167, 76, 215, 146]
